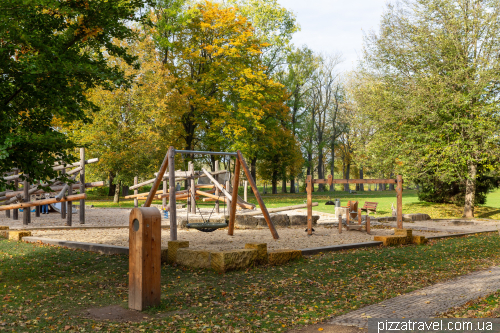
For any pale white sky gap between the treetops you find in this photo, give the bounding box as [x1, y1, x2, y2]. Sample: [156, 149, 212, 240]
[278, 0, 387, 71]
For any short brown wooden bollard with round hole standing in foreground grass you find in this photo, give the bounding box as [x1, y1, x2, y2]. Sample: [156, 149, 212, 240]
[128, 207, 161, 311]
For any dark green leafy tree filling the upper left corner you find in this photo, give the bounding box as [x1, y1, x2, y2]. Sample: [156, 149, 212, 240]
[0, 0, 152, 185]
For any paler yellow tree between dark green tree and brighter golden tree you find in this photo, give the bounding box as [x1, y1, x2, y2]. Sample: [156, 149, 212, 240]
[62, 30, 185, 201]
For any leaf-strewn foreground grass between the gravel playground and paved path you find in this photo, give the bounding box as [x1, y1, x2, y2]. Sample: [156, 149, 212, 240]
[0, 233, 500, 332]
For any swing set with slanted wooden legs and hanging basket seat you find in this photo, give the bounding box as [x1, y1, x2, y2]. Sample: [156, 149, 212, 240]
[144, 146, 279, 241]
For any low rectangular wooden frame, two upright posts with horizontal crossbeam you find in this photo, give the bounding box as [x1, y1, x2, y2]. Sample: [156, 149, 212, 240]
[306, 175, 403, 236]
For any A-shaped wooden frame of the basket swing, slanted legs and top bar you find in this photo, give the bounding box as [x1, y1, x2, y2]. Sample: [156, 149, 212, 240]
[144, 146, 282, 241]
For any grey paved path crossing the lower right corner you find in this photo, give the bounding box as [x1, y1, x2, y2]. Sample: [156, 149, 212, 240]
[326, 266, 500, 328]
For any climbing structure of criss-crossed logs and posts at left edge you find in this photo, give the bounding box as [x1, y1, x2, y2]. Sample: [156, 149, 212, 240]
[0, 148, 104, 226]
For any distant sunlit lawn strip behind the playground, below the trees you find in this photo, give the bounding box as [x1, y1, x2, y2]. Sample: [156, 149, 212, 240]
[82, 189, 500, 219]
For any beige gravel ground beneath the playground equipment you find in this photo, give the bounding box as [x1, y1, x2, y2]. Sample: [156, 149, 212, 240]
[0, 208, 496, 250]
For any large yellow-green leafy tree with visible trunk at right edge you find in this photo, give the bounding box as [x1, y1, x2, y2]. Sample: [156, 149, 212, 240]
[358, 0, 500, 217]
